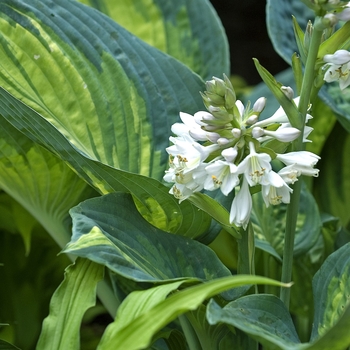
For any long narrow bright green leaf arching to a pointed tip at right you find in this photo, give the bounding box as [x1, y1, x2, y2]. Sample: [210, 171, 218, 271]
[98, 275, 288, 350]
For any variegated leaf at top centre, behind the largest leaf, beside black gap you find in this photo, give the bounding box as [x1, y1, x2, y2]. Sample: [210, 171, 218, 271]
[80, 0, 230, 79]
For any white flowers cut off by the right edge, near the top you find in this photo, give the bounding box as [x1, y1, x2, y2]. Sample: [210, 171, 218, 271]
[323, 49, 350, 90]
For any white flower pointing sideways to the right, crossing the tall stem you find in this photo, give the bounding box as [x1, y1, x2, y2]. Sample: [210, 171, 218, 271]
[276, 151, 321, 177]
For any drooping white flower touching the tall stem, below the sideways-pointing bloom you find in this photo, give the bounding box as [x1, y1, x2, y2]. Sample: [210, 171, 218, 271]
[261, 171, 293, 207]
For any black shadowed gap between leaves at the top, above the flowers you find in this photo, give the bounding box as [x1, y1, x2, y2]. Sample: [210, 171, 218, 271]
[210, 0, 288, 85]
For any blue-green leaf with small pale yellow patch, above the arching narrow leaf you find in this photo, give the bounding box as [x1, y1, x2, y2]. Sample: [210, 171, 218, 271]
[65, 193, 231, 282]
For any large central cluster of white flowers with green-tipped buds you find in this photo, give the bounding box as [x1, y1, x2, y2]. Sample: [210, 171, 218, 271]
[164, 76, 319, 228]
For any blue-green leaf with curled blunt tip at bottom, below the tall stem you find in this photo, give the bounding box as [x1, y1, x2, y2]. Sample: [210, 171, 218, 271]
[207, 294, 300, 350]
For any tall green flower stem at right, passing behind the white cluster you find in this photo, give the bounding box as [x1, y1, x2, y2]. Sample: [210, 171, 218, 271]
[280, 17, 323, 309]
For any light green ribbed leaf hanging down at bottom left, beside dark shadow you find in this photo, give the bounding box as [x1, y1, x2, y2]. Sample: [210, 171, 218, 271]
[37, 259, 104, 350]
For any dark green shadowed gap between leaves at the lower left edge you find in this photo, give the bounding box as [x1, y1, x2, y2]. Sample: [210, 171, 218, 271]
[0, 227, 70, 349]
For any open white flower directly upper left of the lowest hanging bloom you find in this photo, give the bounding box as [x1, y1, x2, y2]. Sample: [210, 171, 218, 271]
[204, 160, 239, 196]
